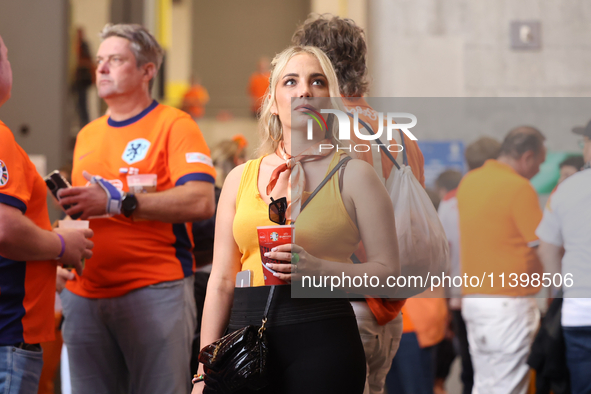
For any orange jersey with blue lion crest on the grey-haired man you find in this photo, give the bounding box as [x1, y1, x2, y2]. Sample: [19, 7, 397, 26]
[68, 101, 215, 298]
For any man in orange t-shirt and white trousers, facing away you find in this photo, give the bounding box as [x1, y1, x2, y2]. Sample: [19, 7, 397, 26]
[457, 127, 546, 394]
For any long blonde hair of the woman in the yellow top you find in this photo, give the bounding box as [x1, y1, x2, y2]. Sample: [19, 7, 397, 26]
[256, 46, 345, 156]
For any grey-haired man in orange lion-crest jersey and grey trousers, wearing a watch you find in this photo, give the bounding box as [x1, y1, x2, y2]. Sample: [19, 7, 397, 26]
[60, 25, 215, 394]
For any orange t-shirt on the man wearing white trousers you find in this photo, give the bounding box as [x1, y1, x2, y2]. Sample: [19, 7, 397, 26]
[457, 160, 542, 297]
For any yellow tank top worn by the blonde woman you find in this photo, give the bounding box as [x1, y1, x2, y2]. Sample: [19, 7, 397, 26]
[232, 154, 361, 286]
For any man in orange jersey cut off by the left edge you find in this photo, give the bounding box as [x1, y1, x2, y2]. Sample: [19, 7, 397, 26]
[0, 33, 92, 394]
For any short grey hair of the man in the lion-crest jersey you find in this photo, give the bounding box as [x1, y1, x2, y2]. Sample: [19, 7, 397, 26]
[100, 23, 164, 90]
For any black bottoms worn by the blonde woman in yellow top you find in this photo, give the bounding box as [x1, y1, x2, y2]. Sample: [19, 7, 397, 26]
[229, 286, 366, 394]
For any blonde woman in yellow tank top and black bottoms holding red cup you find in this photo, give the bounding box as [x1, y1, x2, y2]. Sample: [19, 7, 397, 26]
[193, 47, 399, 394]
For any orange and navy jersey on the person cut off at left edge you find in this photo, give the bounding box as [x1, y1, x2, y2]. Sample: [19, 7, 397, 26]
[0, 121, 57, 346]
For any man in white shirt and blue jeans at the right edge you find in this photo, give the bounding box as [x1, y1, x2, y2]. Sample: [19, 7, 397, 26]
[536, 122, 591, 394]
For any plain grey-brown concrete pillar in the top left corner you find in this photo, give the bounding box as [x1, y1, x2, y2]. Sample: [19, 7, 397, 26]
[0, 0, 71, 171]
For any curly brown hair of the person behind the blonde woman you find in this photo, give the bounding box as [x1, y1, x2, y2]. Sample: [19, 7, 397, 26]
[291, 14, 369, 97]
